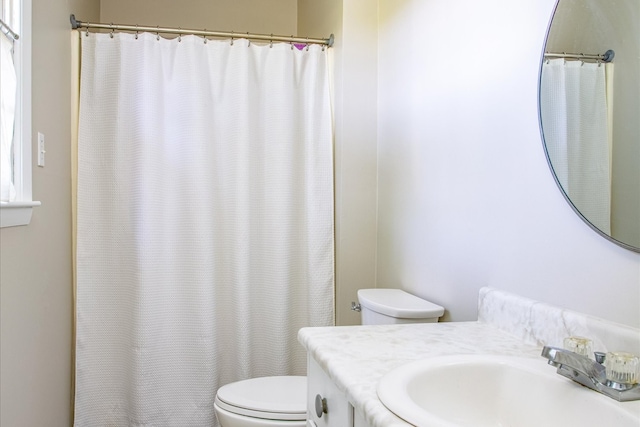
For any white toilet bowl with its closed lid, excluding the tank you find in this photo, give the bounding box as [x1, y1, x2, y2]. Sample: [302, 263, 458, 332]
[213, 376, 307, 427]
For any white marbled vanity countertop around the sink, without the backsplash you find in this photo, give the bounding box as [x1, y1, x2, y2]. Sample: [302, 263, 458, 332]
[298, 322, 552, 427]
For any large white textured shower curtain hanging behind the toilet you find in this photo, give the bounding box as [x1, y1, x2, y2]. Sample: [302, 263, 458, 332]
[75, 33, 334, 427]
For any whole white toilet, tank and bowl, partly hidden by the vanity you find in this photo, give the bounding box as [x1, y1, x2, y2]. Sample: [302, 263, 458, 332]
[214, 289, 444, 427]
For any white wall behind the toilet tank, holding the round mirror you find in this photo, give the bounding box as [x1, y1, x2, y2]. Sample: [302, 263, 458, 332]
[377, 0, 640, 327]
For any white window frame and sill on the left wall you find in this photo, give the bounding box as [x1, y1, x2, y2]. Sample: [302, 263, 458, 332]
[0, 0, 40, 227]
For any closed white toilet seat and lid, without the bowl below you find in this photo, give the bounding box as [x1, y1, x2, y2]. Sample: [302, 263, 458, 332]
[215, 376, 307, 421]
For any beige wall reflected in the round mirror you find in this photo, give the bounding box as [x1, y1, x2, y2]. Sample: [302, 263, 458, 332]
[547, 0, 640, 254]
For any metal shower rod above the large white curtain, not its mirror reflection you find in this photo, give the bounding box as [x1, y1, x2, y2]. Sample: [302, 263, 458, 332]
[70, 15, 333, 47]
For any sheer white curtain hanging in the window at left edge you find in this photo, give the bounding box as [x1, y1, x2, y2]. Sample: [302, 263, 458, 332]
[0, 34, 17, 202]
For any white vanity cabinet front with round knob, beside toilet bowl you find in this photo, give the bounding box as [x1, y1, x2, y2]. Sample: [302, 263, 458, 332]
[307, 356, 353, 427]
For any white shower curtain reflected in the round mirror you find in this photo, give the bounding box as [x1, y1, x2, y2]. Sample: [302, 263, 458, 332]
[540, 59, 611, 234]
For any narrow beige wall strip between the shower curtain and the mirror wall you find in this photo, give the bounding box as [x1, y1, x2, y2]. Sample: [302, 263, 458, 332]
[298, 0, 378, 325]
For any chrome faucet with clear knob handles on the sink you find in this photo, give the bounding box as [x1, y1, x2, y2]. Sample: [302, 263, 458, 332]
[542, 346, 640, 402]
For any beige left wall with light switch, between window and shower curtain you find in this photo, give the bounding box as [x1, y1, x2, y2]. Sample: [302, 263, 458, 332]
[0, 0, 99, 427]
